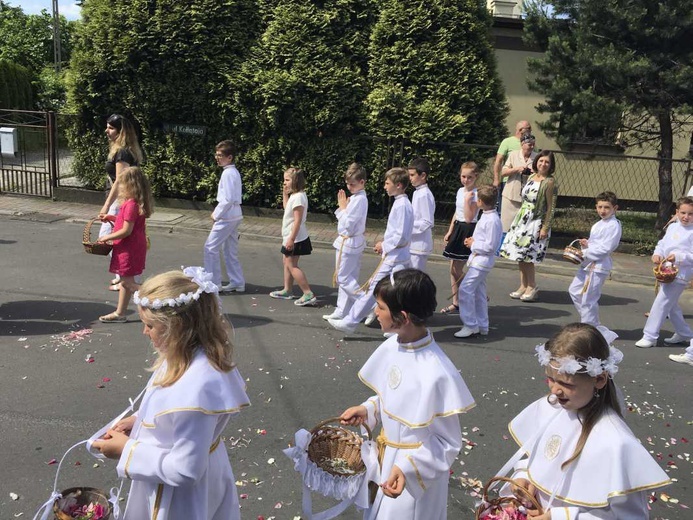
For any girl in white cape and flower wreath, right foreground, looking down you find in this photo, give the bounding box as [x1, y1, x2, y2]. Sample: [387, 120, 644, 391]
[501, 323, 671, 520]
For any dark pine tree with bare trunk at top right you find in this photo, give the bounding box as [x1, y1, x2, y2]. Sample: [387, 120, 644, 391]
[525, 0, 693, 229]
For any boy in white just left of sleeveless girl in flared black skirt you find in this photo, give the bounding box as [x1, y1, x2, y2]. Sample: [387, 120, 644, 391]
[407, 157, 436, 271]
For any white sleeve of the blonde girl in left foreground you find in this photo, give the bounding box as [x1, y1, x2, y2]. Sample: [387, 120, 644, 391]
[117, 411, 218, 487]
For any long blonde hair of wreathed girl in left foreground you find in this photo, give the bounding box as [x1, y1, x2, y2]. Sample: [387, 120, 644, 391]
[139, 271, 234, 387]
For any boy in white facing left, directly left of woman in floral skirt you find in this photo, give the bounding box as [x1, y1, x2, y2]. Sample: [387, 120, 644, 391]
[455, 186, 503, 338]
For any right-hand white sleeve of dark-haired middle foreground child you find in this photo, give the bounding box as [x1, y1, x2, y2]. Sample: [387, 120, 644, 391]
[394, 414, 462, 500]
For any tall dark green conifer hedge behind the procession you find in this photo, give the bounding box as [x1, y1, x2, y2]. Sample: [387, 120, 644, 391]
[70, 0, 506, 210]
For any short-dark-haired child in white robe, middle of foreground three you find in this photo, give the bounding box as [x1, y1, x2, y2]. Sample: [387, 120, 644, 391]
[341, 269, 475, 520]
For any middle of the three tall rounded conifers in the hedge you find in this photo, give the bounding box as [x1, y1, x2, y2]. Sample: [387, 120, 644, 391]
[231, 0, 374, 209]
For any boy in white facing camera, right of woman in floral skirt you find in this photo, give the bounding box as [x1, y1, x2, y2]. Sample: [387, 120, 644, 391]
[568, 191, 621, 334]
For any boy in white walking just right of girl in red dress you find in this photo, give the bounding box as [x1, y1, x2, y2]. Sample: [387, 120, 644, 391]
[204, 140, 245, 292]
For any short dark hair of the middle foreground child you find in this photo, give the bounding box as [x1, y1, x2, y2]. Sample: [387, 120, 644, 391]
[373, 269, 436, 326]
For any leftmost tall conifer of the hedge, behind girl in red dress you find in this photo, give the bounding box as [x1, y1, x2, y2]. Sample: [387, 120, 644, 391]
[70, 0, 259, 194]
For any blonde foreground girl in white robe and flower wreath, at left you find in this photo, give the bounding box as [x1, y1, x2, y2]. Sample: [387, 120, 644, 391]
[92, 267, 250, 520]
